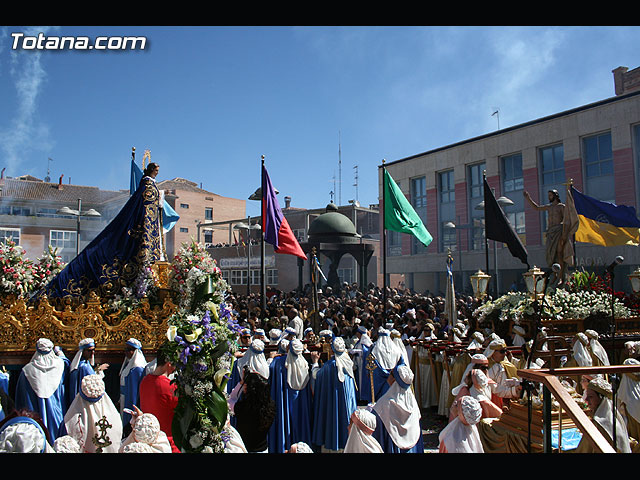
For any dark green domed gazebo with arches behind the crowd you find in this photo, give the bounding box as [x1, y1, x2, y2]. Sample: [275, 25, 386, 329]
[301, 203, 374, 291]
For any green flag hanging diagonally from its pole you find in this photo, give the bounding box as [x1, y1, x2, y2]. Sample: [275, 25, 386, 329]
[383, 169, 433, 247]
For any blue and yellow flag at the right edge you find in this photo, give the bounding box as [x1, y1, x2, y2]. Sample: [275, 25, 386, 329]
[571, 186, 640, 247]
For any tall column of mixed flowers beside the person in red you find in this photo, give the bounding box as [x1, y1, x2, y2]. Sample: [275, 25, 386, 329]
[162, 242, 240, 453]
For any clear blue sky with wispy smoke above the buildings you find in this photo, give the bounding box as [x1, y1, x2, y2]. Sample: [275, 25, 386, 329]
[0, 26, 640, 215]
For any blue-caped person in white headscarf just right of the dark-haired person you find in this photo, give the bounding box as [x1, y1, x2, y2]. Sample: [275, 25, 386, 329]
[268, 338, 313, 453]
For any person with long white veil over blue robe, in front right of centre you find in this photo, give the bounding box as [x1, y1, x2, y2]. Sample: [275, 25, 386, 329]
[372, 365, 424, 453]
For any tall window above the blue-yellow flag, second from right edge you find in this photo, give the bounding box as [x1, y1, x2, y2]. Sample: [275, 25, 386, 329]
[582, 132, 615, 202]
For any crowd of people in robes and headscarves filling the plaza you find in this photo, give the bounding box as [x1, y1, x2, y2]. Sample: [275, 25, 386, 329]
[0, 284, 640, 453]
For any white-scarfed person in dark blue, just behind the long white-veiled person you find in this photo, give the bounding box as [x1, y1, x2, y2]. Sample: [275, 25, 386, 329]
[359, 327, 404, 404]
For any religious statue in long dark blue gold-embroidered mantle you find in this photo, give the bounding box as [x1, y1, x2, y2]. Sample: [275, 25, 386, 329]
[35, 163, 164, 298]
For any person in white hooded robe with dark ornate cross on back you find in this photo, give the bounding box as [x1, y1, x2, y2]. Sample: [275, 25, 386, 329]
[64, 374, 123, 453]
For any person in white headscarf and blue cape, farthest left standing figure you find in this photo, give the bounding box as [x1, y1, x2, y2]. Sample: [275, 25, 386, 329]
[15, 338, 67, 440]
